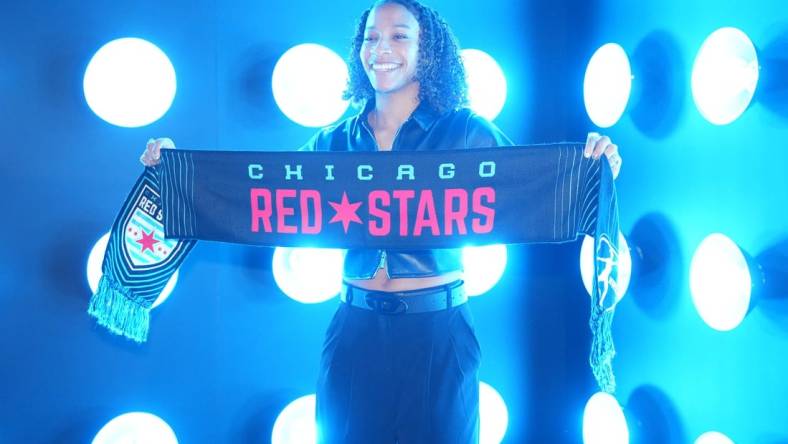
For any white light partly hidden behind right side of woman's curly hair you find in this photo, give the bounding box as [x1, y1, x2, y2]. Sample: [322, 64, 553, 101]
[460, 49, 506, 120]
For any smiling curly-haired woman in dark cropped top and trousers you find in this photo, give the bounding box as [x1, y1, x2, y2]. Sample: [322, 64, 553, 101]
[141, 0, 621, 444]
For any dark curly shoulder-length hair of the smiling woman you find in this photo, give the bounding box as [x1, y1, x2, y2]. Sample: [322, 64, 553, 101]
[342, 0, 468, 114]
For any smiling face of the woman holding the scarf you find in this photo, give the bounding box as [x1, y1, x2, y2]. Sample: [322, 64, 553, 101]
[359, 3, 419, 94]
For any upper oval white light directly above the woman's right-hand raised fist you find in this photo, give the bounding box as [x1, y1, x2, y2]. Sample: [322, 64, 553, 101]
[583, 43, 632, 128]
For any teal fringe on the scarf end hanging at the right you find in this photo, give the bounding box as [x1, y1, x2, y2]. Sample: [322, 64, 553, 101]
[589, 301, 616, 394]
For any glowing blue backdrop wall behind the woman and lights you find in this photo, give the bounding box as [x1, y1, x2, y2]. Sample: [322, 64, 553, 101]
[0, 0, 788, 444]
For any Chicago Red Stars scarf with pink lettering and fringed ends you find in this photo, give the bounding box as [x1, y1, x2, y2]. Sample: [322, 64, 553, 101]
[88, 143, 619, 393]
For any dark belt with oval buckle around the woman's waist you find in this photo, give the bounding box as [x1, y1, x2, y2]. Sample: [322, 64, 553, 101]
[339, 280, 468, 314]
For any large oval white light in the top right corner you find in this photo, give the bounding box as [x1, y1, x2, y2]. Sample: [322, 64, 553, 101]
[692, 28, 759, 125]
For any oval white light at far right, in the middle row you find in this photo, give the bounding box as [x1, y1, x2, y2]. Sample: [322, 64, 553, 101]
[690, 233, 752, 331]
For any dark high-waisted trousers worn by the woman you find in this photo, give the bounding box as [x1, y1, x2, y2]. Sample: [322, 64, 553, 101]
[316, 303, 481, 444]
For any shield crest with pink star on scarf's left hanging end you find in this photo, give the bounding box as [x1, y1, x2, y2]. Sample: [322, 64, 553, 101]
[123, 184, 178, 269]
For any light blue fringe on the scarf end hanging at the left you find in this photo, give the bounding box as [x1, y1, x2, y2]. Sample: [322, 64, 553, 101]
[88, 274, 150, 343]
